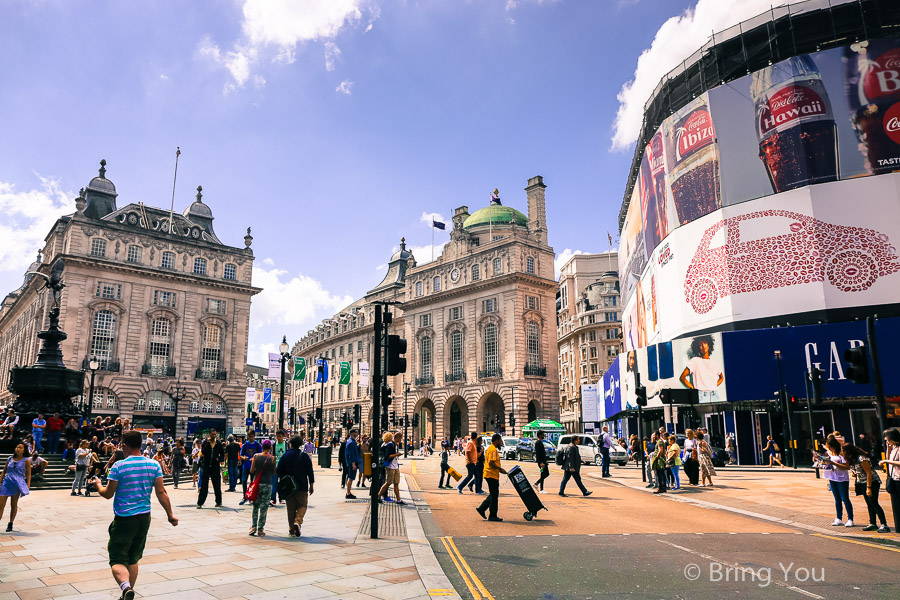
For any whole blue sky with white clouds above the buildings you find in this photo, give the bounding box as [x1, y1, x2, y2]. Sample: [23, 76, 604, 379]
[0, 0, 778, 365]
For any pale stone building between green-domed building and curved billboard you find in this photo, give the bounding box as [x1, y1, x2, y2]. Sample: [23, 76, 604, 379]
[556, 252, 622, 432]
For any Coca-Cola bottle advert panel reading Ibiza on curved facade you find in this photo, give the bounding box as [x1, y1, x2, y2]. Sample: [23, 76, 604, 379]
[665, 94, 722, 225]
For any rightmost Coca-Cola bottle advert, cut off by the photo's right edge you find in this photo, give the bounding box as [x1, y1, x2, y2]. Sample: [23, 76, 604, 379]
[844, 38, 900, 174]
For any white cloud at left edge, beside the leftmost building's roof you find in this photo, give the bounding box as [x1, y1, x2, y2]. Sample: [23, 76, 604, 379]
[0, 173, 76, 284]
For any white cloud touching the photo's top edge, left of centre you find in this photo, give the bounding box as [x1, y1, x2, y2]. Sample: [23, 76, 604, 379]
[198, 0, 372, 93]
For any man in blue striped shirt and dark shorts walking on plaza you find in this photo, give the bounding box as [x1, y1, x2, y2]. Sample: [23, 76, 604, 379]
[91, 431, 178, 600]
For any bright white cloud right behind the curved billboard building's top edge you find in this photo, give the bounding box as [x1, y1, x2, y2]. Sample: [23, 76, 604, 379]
[612, 0, 780, 150]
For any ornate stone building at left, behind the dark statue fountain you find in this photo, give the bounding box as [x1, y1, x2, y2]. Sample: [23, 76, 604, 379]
[0, 161, 261, 434]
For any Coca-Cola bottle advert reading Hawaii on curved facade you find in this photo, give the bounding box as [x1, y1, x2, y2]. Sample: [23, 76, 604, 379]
[750, 55, 839, 193]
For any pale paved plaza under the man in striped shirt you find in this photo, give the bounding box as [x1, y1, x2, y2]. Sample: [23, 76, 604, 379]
[0, 469, 459, 600]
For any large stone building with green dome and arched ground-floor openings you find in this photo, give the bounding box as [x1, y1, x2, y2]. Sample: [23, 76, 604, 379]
[294, 176, 559, 440]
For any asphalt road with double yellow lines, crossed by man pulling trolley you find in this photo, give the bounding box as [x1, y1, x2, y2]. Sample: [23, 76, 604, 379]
[401, 457, 900, 600]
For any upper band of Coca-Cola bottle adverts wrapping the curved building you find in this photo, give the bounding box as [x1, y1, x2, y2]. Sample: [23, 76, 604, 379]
[619, 38, 900, 310]
